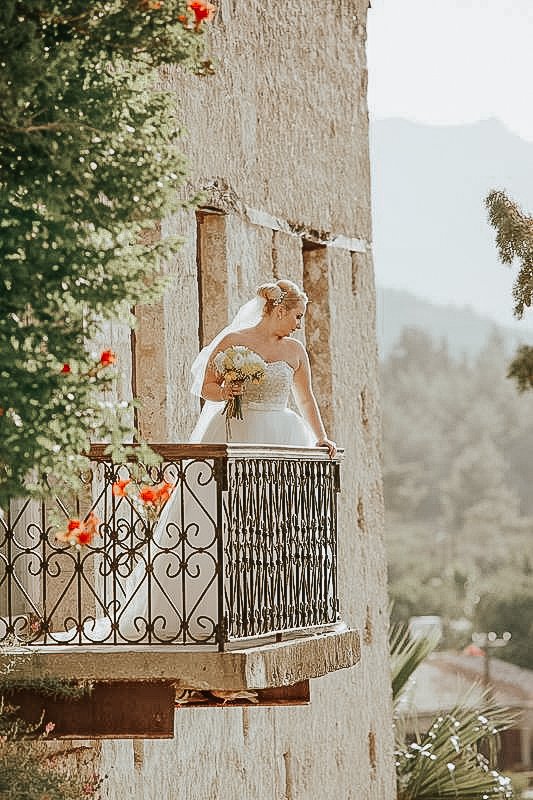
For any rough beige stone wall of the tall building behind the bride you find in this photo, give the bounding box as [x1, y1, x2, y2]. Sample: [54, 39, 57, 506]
[96, 0, 395, 800]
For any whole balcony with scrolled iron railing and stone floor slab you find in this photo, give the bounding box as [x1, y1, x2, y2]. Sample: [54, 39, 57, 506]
[0, 444, 359, 732]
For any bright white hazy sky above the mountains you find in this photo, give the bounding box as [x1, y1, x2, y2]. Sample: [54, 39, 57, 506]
[368, 0, 533, 141]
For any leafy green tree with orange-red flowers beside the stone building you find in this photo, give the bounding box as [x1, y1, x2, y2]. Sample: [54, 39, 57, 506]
[0, 0, 209, 507]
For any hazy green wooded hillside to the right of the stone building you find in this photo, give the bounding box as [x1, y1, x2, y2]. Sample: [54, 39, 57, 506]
[382, 322, 533, 657]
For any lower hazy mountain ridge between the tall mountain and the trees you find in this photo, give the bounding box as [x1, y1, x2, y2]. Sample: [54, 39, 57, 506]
[377, 286, 533, 359]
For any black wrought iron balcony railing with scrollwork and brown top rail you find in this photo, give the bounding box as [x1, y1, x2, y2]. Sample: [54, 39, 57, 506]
[0, 445, 339, 650]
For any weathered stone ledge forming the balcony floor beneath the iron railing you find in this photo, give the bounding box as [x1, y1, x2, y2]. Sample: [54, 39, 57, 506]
[0, 628, 360, 690]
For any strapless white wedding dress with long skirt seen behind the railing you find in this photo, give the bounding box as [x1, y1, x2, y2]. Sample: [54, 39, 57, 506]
[52, 360, 315, 644]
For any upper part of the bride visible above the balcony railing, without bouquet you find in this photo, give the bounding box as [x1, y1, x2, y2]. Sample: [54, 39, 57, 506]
[190, 280, 336, 458]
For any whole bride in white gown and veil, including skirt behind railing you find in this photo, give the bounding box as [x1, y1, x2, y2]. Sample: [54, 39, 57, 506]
[53, 280, 337, 643]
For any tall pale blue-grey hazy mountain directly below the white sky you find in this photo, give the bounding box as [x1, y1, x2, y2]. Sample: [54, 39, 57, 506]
[370, 119, 533, 325]
